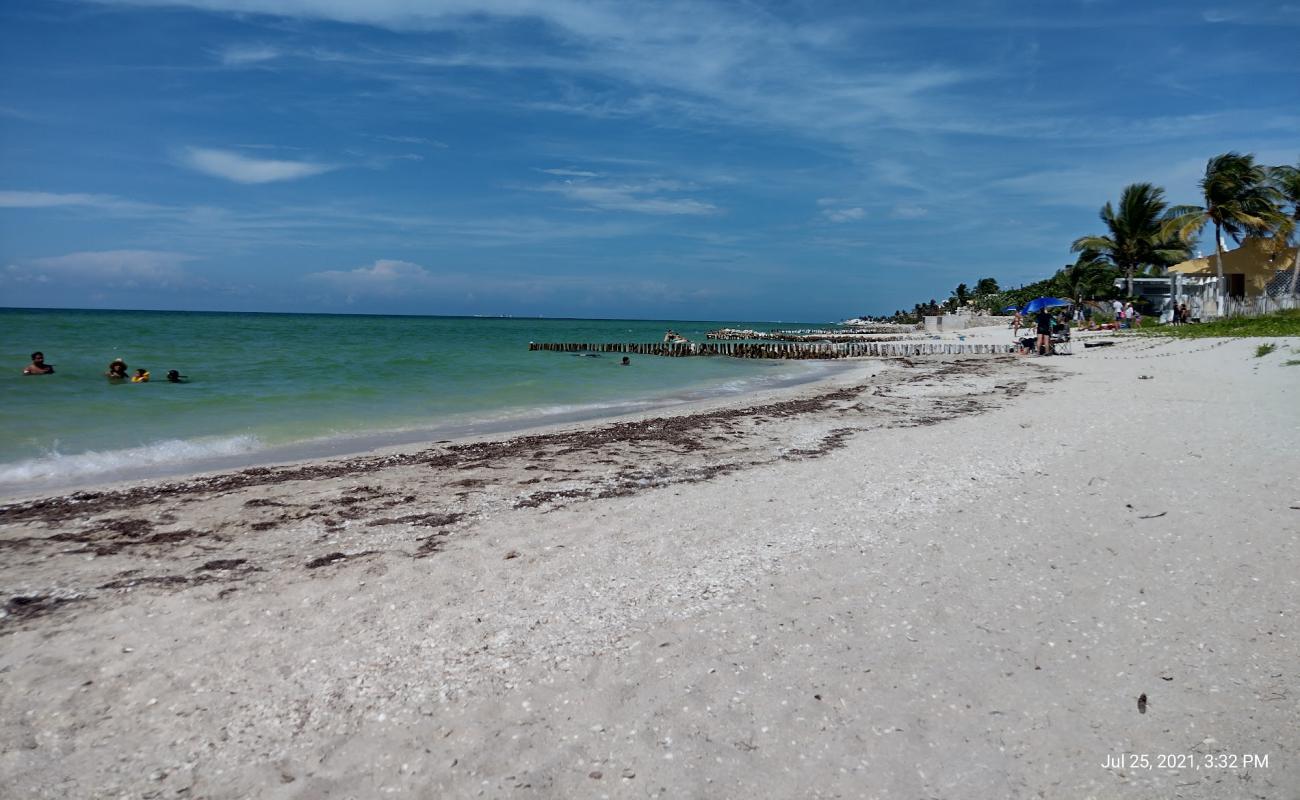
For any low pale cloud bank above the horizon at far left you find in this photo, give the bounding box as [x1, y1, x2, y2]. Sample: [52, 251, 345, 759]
[4, 250, 194, 289]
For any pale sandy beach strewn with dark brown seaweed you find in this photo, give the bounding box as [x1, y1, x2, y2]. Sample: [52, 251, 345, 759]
[0, 329, 1300, 799]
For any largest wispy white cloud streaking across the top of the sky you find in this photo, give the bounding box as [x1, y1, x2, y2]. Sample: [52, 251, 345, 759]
[91, 0, 988, 148]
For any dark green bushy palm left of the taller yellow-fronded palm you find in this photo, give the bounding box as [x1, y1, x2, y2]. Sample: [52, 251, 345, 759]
[1070, 183, 1187, 297]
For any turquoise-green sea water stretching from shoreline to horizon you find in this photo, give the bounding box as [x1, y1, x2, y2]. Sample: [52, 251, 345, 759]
[0, 310, 842, 494]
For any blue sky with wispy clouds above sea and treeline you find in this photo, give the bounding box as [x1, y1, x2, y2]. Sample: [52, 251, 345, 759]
[0, 0, 1300, 321]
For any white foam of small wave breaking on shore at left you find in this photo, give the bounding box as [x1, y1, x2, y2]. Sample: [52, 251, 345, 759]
[0, 436, 261, 484]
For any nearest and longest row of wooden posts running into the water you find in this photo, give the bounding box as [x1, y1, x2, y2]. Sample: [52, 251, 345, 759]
[528, 342, 1015, 359]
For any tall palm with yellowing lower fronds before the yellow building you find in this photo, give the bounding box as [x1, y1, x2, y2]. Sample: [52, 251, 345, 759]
[1167, 152, 1283, 313]
